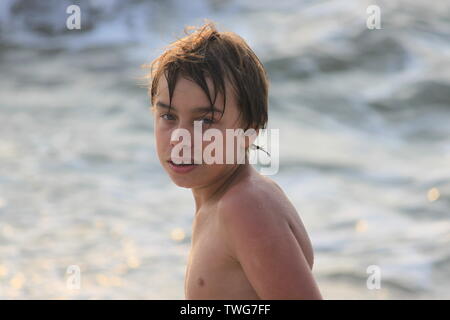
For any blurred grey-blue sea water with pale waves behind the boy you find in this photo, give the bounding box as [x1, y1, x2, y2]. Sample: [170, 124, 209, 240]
[0, 0, 450, 299]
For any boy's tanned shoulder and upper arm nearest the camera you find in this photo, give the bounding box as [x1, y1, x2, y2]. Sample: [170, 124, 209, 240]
[214, 171, 321, 299]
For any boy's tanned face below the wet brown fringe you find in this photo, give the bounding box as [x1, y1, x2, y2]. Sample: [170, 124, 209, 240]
[152, 75, 248, 188]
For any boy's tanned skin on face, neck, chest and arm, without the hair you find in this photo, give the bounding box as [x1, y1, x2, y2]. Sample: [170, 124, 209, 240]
[152, 77, 322, 300]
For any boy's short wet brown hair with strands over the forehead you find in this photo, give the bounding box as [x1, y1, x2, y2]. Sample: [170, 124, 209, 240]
[148, 21, 269, 131]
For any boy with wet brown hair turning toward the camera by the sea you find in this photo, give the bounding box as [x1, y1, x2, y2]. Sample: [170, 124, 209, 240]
[149, 22, 322, 300]
